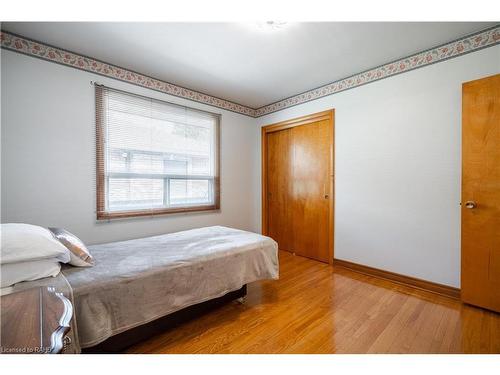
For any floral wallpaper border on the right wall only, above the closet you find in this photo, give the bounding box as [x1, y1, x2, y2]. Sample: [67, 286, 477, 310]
[255, 25, 500, 117]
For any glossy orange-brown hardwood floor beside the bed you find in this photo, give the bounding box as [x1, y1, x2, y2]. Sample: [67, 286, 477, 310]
[127, 251, 500, 353]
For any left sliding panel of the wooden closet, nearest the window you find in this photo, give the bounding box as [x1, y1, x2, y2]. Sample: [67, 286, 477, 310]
[267, 129, 293, 251]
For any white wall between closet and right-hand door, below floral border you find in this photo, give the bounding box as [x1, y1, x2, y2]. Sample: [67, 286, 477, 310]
[258, 46, 500, 287]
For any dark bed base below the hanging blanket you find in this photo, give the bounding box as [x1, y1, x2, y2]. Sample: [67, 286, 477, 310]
[82, 285, 247, 353]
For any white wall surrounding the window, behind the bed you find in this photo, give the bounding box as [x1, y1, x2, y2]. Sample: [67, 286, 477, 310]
[1, 50, 260, 244]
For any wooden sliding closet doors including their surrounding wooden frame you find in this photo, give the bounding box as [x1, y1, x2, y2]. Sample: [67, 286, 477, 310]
[262, 111, 334, 263]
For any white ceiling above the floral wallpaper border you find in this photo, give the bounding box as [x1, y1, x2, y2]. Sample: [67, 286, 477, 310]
[2, 22, 495, 108]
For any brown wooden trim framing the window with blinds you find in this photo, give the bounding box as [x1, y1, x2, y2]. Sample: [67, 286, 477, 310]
[94, 83, 221, 220]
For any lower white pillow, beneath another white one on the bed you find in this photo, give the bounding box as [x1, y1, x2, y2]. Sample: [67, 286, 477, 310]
[0, 259, 61, 288]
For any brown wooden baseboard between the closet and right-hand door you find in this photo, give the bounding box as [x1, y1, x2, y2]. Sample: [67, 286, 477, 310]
[333, 259, 460, 299]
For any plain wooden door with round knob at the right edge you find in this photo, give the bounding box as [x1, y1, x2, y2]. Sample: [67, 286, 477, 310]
[461, 74, 500, 311]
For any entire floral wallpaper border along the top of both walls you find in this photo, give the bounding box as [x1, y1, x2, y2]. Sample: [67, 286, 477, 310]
[0, 25, 500, 117]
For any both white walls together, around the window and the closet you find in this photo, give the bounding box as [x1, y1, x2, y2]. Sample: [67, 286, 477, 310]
[1, 46, 500, 287]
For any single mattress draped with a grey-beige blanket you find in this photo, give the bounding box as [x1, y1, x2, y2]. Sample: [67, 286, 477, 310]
[62, 226, 279, 348]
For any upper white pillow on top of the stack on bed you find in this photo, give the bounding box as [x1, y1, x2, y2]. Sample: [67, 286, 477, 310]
[0, 224, 70, 264]
